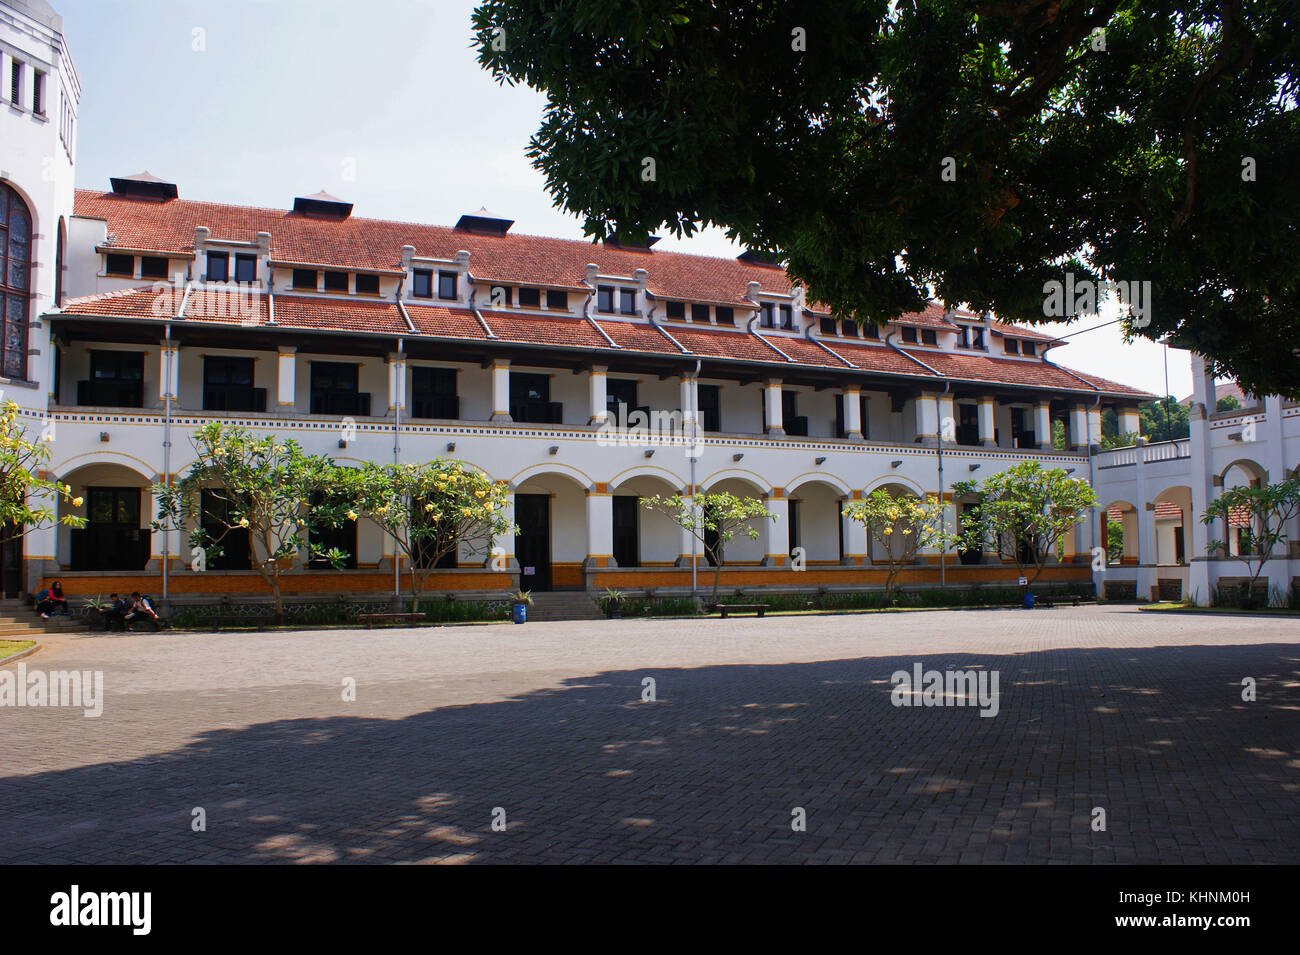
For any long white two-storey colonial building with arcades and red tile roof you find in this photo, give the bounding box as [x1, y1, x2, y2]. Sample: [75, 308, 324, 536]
[0, 0, 1300, 613]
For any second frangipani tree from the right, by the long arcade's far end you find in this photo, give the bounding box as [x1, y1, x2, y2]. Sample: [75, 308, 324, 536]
[953, 461, 1097, 586]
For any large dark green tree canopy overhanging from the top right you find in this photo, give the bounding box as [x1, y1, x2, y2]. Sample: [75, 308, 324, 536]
[473, 0, 1300, 396]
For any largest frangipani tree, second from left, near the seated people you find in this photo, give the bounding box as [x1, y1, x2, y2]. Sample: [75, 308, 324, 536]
[153, 422, 347, 618]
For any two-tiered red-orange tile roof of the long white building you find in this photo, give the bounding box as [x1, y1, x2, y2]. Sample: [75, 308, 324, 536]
[64, 190, 1151, 399]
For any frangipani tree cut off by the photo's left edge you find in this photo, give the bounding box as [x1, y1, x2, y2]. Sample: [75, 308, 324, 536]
[0, 399, 86, 543]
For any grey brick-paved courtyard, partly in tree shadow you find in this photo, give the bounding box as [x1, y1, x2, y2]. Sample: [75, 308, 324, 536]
[0, 608, 1300, 863]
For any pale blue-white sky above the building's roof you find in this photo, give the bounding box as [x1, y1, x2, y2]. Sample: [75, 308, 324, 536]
[63, 0, 1191, 398]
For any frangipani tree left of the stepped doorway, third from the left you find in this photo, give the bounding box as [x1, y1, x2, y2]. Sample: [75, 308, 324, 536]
[341, 459, 517, 611]
